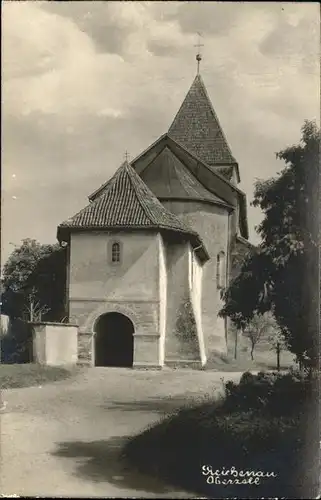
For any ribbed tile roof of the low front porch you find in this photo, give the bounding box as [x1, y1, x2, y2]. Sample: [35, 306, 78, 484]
[57, 161, 208, 260]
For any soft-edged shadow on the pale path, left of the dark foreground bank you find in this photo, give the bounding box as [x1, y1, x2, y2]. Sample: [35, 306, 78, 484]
[52, 436, 179, 494]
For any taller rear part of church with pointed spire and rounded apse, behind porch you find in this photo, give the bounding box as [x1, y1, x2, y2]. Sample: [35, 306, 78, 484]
[132, 73, 249, 359]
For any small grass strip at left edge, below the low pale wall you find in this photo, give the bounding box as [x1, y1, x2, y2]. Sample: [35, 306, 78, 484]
[0, 363, 80, 389]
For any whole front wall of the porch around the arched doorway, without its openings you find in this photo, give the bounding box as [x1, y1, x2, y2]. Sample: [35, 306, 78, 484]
[69, 231, 160, 366]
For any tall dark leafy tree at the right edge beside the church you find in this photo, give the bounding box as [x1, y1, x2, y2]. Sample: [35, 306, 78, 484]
[220, 121, 320, 367]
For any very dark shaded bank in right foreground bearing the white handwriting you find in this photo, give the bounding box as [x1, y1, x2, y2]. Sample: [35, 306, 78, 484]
[125, 407, 312, 498]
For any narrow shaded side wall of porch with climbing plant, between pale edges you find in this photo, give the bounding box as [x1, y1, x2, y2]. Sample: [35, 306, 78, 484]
[165, 240, 200, 364]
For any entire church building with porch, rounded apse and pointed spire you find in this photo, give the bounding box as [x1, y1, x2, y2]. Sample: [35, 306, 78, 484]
[57, 74, 250, 367]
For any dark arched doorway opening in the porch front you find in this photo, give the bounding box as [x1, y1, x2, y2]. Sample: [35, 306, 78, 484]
[95, 312, 134, 367]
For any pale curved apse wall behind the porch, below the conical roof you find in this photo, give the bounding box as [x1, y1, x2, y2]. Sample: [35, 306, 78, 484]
[163, 201, 229, 358]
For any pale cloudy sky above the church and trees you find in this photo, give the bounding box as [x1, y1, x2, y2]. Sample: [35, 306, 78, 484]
[1, 1, 320, 265]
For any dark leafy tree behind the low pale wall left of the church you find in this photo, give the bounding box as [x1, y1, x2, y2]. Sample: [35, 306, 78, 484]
[2, 239, 66, 321]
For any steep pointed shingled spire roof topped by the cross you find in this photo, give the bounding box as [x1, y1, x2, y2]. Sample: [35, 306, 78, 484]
[168, 75, 236, 165]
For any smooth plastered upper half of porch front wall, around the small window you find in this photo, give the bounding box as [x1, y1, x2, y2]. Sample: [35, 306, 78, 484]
[69, 232, 158, 300]
